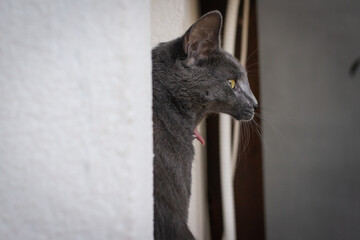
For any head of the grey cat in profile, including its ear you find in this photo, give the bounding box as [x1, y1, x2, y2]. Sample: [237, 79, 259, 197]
[182, 11, 258, 120]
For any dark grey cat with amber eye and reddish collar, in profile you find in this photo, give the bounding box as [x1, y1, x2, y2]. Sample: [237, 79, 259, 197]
[152, 11, 258, 240]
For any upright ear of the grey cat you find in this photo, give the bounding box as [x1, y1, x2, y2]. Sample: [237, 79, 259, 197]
[183, 11, 222, 64]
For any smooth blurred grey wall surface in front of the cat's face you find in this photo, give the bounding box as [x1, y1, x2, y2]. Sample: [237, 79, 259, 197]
[258, 1, 360, 239]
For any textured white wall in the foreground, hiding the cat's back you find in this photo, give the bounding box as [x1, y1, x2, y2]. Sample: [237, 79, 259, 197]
[0, 0, 153, 240]
